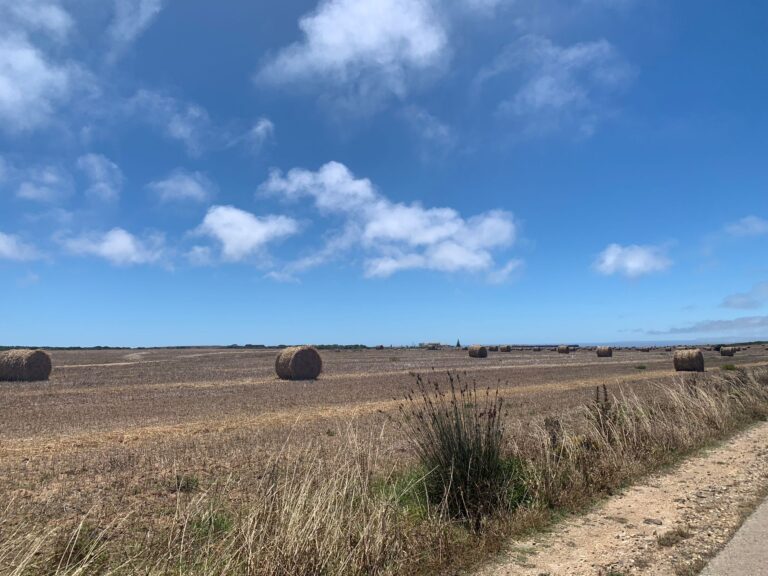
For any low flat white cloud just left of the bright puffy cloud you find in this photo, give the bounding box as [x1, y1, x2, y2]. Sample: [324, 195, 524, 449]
[63, 228, 164, 266]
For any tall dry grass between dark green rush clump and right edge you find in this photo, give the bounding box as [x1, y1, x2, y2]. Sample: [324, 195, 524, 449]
[512, 369, 768, 508]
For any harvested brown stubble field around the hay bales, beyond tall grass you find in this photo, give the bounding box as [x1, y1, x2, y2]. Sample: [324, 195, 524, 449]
[0, 347, 768, 571]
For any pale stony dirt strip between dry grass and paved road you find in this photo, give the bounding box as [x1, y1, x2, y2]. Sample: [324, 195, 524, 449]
[478, 423, 768, 576]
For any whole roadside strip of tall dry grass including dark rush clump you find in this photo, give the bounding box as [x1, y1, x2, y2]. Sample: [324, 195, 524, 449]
[0, 369, 768, 576]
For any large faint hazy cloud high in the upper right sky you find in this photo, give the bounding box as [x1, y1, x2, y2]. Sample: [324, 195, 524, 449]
[477, 35, 634, 135]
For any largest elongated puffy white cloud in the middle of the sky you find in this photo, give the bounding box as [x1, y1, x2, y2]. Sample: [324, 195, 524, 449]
[261, 162, 516, 277]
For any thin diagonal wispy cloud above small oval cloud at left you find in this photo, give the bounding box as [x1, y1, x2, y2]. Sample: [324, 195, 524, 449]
[128, 90, 213, 156]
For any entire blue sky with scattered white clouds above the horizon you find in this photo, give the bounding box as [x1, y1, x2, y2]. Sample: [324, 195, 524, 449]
[0, 0, 768, 346]
